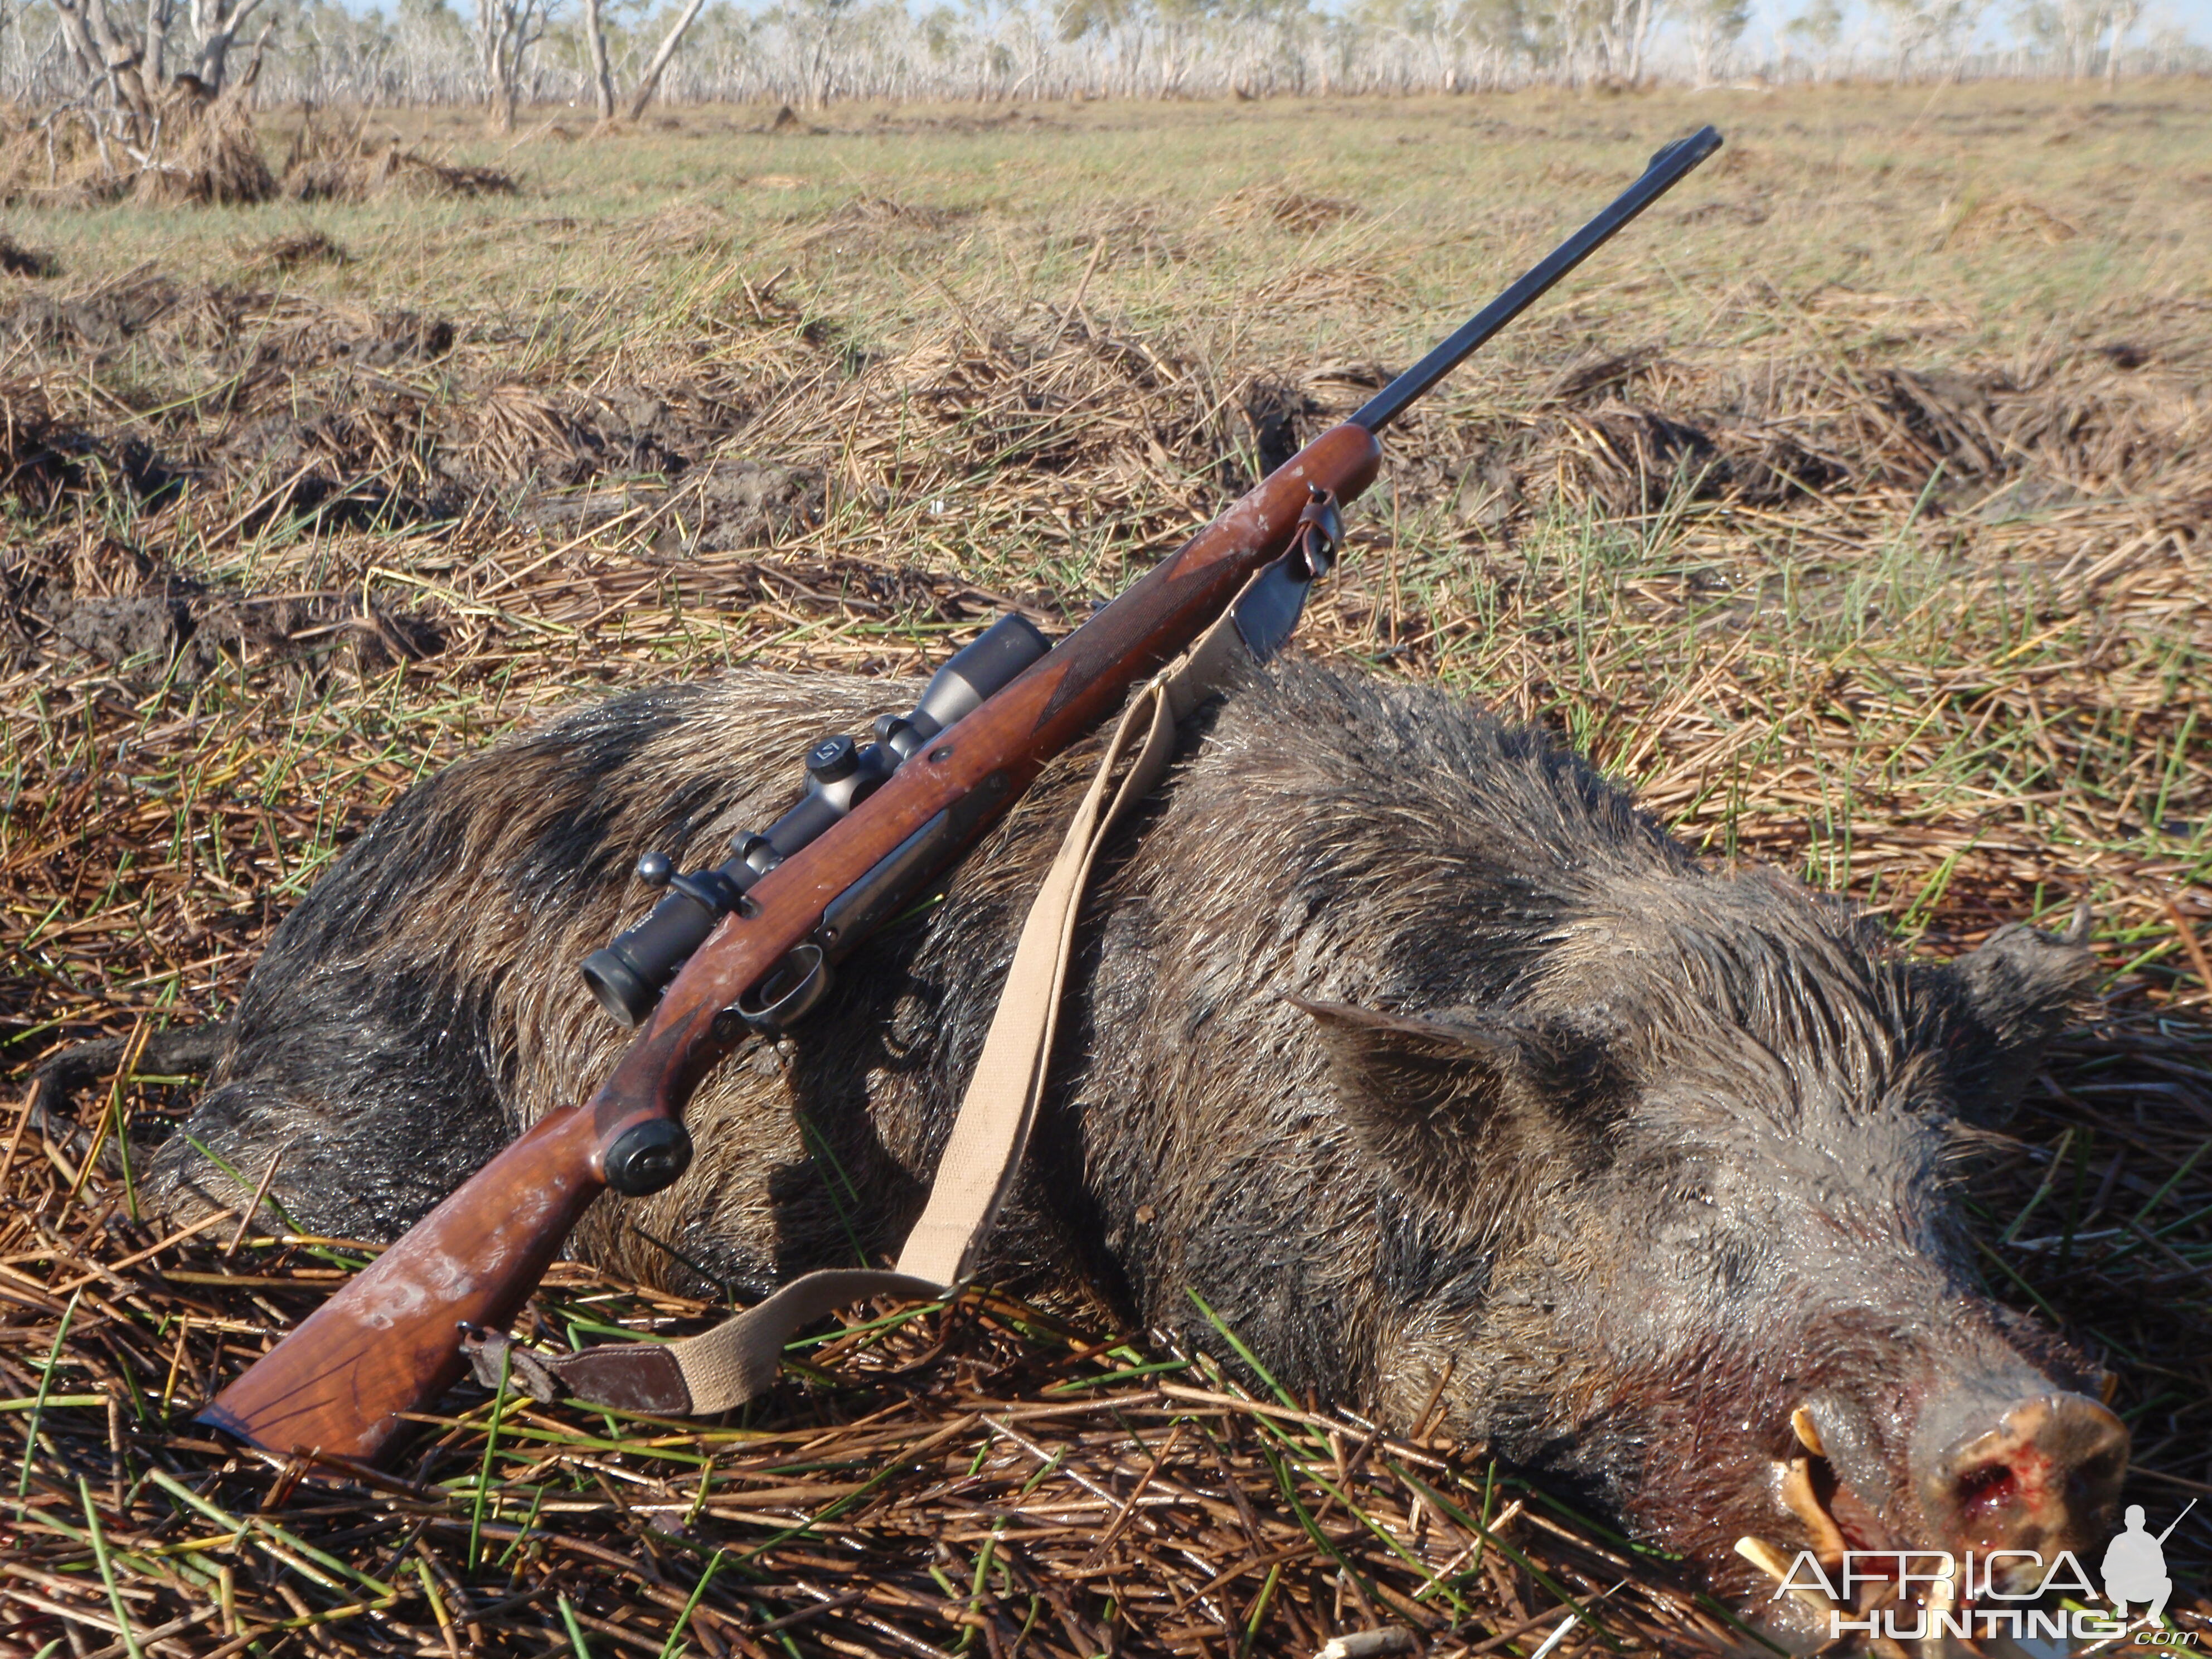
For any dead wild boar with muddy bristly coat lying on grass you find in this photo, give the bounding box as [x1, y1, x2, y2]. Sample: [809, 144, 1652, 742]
[157, 663, 2128, 1615]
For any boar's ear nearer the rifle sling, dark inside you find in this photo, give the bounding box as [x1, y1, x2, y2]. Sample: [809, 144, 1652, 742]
[1285, 996, 1522, 1210]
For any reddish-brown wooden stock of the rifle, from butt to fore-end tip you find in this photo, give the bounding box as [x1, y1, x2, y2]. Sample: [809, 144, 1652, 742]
[199, 423, 1382, 1460]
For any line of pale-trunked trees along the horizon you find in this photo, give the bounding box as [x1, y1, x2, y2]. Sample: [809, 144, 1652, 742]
[0, 0, 2208, 133]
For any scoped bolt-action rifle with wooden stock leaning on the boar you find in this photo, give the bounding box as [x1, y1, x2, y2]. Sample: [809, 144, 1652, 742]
[201, 126, 1721, 1460]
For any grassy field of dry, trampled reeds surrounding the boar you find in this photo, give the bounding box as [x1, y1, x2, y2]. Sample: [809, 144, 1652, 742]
[0, 80, 2212, 1659]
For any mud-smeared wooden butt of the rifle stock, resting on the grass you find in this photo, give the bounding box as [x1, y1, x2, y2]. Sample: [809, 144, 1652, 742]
[197, 1108, 604, 1462]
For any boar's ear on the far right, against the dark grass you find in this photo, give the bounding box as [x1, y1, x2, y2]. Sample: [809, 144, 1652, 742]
[1951, 905, 2097, 1117]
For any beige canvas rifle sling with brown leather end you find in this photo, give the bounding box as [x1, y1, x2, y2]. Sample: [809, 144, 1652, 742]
[464, 615, 1252, 1416]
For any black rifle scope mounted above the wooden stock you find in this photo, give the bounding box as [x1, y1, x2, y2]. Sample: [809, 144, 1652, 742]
[584, 613, 1053, 1026]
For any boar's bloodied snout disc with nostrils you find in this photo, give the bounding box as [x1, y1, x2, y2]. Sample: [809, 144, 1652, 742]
[1911, 1371, 2128, 1573]
